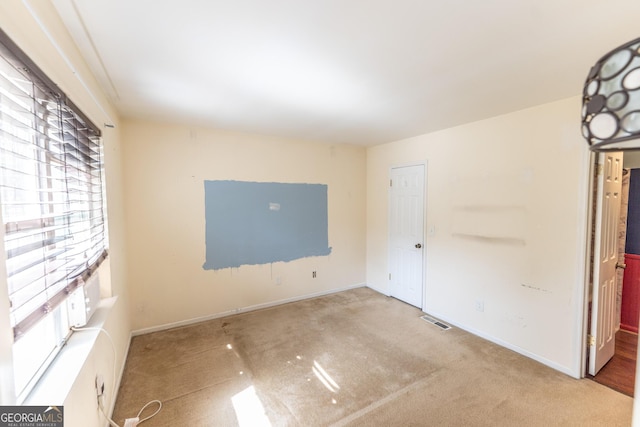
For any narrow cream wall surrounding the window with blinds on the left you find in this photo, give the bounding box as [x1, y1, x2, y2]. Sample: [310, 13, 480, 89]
[0, 0, 131, 427]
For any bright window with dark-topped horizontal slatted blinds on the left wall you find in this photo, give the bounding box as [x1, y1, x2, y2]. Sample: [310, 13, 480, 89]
[0, 31, 106, 400]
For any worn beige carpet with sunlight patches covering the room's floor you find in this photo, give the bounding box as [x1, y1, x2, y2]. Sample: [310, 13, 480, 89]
[114, 288, 633, 427]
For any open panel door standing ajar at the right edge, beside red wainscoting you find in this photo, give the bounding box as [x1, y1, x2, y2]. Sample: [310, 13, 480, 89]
[589, 152, 622, 375]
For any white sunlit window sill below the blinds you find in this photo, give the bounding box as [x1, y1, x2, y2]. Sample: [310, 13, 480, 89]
[18, 297, 117, 406]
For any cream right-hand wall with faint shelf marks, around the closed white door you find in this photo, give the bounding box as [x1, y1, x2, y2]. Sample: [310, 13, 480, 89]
[367, 98, 589, 376]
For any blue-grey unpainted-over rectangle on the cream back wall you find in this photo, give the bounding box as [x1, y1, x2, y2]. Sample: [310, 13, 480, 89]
[203, 181, 331, 270]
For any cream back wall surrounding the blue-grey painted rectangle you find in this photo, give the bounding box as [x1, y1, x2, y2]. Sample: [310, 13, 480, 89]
[123, 121, 366, 330]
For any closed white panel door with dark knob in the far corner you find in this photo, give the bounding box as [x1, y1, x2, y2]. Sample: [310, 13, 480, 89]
[389, 165, 425, 308]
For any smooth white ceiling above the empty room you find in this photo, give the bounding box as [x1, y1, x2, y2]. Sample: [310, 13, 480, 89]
[54, 0, 640, 145]
